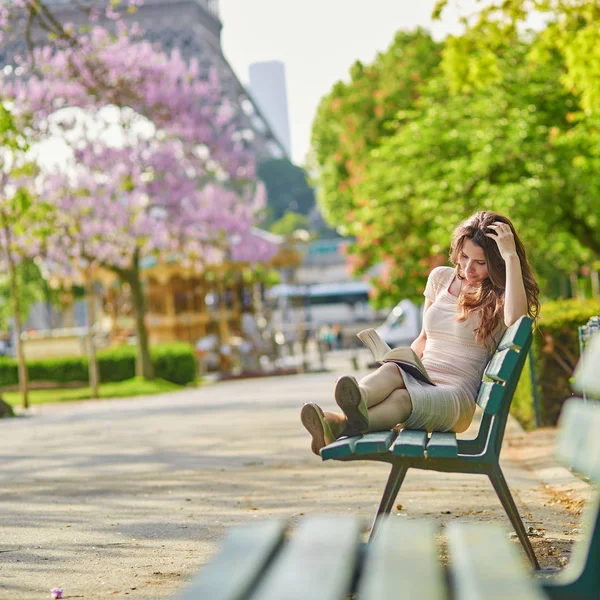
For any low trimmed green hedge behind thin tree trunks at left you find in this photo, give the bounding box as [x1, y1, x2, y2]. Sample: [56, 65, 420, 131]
[0, 343, 196, 387]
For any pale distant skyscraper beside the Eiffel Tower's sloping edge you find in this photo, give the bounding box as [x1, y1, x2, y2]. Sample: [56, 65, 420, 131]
[249, 60, 290, 156]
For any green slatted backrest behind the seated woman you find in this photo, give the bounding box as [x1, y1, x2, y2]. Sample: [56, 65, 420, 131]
[476, 317, 533, 455]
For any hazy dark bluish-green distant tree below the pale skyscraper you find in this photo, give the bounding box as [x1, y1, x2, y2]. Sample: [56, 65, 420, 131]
[258, 158, 315, 227]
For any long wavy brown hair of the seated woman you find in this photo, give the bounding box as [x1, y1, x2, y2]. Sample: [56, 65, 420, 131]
[450, 211, 540, 344]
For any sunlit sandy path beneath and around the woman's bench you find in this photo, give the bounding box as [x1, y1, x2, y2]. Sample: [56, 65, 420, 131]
[0, 373, 586, 600]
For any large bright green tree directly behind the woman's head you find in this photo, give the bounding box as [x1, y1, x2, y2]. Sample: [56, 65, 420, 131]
[338, 44, 600, 310]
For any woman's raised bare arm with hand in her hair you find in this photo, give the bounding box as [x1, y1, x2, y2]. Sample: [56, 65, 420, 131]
[486, 221, 528, 327]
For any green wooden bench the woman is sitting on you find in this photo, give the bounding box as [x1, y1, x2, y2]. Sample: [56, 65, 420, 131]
[321, 317, 539, 569]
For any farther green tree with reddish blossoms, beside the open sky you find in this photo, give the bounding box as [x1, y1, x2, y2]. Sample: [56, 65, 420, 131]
[311, 29, 441, 235]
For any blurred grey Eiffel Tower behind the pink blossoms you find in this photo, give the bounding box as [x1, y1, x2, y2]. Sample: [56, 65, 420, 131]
[0, 0, 287, 162]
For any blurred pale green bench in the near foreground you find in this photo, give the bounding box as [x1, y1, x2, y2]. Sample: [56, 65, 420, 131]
[172, 400, 600, 600]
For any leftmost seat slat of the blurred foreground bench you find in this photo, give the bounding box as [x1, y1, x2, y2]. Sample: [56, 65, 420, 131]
[178, 520, 285, 600]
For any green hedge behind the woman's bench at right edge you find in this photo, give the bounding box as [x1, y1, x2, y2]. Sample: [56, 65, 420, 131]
[511, 299, 600, 427]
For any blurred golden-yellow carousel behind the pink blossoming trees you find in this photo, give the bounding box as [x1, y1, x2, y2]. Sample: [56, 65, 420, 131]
[23, 229, 303, 358]
